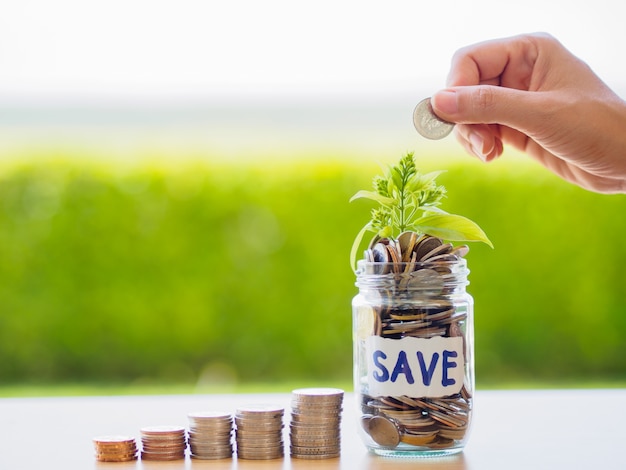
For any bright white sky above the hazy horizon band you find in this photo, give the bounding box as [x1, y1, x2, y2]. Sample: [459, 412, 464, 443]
[0, 0, 626, 105]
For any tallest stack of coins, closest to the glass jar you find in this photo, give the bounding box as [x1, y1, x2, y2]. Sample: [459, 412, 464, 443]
[289, 388, 343, 459]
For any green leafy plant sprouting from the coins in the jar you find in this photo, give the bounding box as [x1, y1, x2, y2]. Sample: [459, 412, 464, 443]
[350, 152, 493, 267]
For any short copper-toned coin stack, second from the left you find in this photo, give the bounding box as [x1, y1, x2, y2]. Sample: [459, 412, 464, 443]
[141, 426, 187, 460]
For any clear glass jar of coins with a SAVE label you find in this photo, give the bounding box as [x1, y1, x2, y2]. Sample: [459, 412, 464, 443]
[352, 258, 474, 457]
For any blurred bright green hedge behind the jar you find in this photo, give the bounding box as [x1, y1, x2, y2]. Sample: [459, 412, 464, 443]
[0, 155, 626, 386]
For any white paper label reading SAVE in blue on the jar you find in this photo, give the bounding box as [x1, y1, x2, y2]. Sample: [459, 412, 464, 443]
[367, 336, 465, 397]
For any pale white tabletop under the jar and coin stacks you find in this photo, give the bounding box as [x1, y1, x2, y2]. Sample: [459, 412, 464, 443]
[0, 389, 626, 470]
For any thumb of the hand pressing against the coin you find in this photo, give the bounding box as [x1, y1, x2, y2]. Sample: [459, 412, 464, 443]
[431, 85, 539, 129]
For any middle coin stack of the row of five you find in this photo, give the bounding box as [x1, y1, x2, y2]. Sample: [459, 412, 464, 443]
[187, 411, 233, 460]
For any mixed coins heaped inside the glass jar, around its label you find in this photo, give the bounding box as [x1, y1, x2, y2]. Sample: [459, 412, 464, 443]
[361, 232, 472, 449]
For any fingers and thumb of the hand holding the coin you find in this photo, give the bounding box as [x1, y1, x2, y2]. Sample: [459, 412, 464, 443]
[431, 35, 552, 162]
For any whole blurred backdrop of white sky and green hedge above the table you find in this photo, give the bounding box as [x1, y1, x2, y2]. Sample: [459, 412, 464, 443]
[0, 0, 626, 396]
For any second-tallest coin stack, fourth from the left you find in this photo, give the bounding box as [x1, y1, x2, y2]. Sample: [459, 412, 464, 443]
[235, 405, 284, 460]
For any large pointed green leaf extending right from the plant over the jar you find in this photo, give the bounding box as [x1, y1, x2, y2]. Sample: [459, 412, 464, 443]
[414, 214, 493, 248]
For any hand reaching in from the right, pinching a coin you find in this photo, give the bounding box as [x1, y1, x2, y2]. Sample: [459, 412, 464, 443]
[431, 34, 626, 193]
